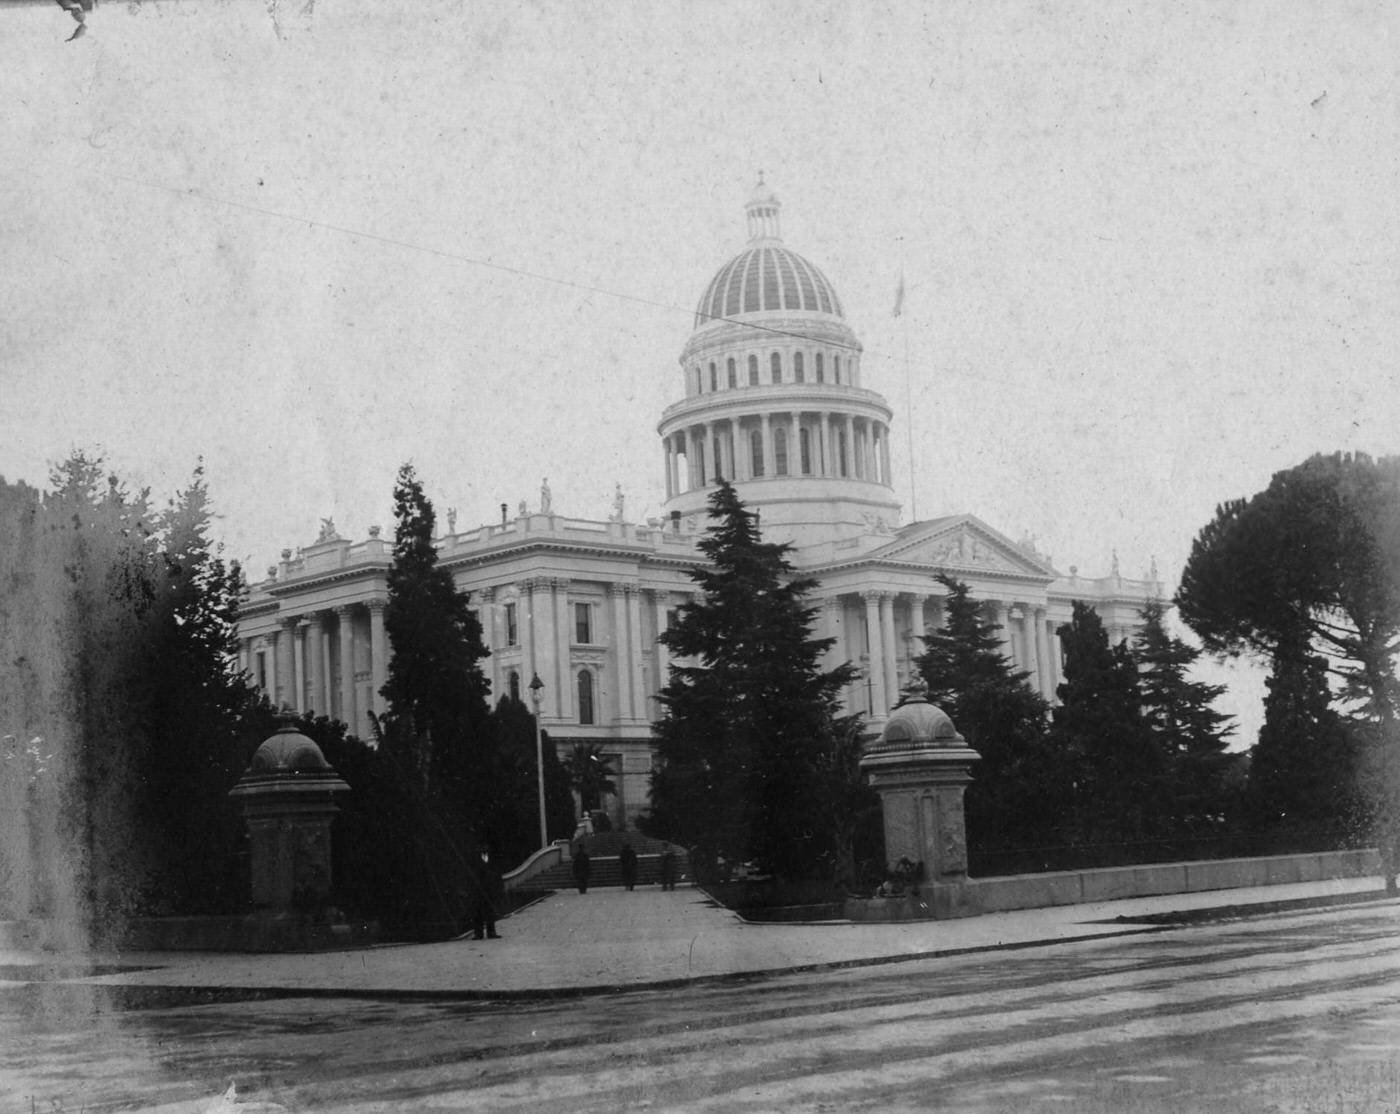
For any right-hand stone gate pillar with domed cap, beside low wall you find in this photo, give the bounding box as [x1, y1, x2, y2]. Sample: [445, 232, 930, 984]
[861, 680, 977, 919]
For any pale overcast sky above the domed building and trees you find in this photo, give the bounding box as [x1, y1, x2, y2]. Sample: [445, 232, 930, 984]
[0, 0, 1400, 738]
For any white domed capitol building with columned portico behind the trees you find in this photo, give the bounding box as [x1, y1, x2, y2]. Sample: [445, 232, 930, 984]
[239, 181, 1161, 827]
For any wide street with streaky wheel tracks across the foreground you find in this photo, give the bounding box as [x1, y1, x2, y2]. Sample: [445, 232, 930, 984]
[0, 903, 1400, 1114]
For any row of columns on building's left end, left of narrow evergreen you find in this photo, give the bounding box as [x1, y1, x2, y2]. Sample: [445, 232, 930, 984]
[239, 599, 389, 732]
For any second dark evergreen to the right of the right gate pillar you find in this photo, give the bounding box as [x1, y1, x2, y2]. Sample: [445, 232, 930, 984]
[1050, 600, 1169, 844]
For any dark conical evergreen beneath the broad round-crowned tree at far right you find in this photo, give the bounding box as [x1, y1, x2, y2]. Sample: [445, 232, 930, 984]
[1246, 638, 1366, 838]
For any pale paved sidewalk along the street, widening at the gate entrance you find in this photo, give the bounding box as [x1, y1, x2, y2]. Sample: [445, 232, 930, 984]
[0, 877, 1383, 998]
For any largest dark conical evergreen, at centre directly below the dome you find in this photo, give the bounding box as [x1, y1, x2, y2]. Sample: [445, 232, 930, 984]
[647, 480, 855, 877]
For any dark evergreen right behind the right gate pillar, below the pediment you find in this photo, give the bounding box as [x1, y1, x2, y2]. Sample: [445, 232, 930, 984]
[916, 574, 1054, 852]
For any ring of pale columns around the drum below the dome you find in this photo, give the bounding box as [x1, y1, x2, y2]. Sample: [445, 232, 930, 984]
[661, 410, 890, 500]
